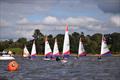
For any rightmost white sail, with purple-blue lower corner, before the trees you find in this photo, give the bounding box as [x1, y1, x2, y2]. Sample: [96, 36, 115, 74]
[100, 36, 110, 55]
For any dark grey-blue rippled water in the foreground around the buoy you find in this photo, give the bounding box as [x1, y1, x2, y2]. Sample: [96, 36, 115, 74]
[0, 57, 120, 80]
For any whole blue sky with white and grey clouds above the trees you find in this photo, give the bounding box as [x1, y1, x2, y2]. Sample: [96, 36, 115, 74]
[0, 0, 120, 40]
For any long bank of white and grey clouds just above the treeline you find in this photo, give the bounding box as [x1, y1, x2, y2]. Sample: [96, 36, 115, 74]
[0, 16, 119, 39]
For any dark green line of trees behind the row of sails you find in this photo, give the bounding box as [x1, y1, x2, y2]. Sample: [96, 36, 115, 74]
[0, 29, 120, 54]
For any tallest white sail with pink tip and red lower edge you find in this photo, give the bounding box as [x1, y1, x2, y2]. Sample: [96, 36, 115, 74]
[63, 25, 70, 56]
